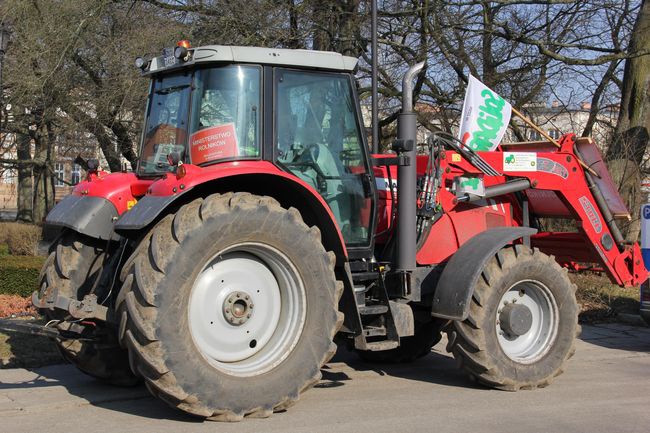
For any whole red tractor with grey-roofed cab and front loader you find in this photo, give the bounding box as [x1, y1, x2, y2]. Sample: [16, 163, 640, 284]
[33, 44, 648, 420]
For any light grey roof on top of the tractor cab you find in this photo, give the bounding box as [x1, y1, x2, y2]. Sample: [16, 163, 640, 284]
[147, 45, 358, 74]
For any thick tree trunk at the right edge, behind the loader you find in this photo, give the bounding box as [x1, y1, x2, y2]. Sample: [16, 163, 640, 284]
[606, 0, 650, 166]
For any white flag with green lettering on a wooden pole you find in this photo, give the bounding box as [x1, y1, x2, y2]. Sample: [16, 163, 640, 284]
[458, 75, 512, 151]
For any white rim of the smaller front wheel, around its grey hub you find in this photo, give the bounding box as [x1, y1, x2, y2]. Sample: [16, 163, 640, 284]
[495, 280, 559, 364]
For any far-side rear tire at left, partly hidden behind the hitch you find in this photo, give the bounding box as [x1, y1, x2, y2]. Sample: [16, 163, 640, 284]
[39, 231, 139, 386]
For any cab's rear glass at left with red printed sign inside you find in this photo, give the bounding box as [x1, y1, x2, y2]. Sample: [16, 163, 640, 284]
[139, 65, 261, 175]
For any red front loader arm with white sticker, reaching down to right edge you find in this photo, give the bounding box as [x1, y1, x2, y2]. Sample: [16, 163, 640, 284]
[441, 134, 648, 286]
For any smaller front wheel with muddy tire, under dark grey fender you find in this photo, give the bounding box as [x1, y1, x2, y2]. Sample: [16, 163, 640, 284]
[447, 245, 580, 391]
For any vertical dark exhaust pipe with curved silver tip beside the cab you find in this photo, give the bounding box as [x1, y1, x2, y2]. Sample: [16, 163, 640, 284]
[395, 62, 424, 276]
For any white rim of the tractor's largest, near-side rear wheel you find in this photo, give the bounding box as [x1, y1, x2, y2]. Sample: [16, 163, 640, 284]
[188, 242, 306, 376]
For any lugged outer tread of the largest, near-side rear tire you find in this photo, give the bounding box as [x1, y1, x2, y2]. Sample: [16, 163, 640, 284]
[119, 193, 343, 422]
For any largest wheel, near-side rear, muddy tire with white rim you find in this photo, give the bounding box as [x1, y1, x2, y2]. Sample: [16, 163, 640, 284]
[120, 193, 343, 421]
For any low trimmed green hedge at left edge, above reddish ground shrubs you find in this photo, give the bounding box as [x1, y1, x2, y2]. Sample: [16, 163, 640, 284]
[0, 256, 45, 297]
